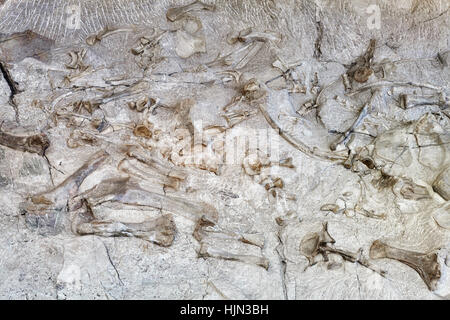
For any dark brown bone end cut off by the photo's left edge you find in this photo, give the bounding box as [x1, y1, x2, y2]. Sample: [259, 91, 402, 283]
[0, 130, 50, 156]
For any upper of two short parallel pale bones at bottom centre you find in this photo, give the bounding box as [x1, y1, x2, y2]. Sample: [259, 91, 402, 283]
[193, 216, 264, 248]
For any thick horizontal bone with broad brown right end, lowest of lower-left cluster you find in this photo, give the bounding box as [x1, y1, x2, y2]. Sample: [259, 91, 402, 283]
[76, 214, 176, 247]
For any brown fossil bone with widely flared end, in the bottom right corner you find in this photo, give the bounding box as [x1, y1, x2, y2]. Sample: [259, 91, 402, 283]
[370, 240, 441, 291]
